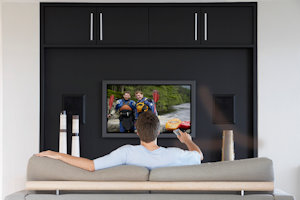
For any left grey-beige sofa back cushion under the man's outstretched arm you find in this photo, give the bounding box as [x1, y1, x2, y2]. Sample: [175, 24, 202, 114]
[27, 156, 149, 181]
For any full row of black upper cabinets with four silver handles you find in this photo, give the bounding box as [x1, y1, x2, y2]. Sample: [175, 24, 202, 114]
[42, 4, 256, 46]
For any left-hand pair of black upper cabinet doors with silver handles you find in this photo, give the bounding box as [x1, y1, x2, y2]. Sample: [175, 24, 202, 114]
[44, 6, 148, 45]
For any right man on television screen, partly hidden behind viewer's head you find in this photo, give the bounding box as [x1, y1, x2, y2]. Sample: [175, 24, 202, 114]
[135, 91, 157, 119]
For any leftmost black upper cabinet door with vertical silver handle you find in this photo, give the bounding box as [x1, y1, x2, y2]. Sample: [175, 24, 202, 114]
[41, 6, 97, 45]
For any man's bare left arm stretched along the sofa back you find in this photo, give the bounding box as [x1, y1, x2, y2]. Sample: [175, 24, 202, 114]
[35, 150, 95, 172]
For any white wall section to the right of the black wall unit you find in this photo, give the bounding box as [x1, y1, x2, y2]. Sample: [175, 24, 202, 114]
[258, 0, 300, 199]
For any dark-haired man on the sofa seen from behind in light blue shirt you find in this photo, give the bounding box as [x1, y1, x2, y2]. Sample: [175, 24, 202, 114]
[36, 112, 203, 171]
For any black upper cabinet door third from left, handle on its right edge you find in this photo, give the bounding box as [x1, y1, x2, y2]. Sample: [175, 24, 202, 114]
[149, 7, 200, 44]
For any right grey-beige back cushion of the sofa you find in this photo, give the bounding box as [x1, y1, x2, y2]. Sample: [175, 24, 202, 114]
[149, 158, 274, 181]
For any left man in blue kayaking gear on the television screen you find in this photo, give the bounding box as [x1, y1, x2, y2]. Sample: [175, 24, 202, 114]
[108, 91, 135, 133]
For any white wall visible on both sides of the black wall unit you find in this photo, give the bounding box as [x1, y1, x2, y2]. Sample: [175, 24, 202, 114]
[0, 0, 300, 199]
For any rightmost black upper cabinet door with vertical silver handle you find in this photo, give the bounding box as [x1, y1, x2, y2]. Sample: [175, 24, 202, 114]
[201, 6, 254, 45]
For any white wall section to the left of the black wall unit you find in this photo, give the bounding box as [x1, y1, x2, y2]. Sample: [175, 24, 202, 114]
[2, 3, 39, 200]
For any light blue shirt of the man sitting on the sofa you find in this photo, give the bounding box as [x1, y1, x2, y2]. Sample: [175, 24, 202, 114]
[93, 145, 201, 170]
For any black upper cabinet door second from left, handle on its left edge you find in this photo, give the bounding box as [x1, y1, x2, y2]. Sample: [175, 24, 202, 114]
[97, 7, 148, 44]
